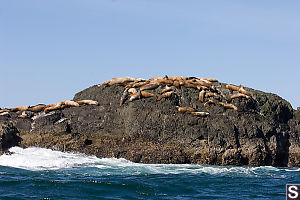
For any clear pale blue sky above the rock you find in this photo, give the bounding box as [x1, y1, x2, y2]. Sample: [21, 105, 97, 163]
[0, 0, 300, 109]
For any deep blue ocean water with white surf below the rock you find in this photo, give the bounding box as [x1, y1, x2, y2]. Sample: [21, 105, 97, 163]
[0, 147, 300, 200]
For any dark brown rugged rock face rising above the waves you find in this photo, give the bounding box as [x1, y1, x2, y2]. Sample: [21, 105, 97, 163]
[0, 78, 300, 167]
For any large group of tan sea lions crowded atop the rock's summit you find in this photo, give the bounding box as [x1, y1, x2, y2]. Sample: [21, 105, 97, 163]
[99, 76, 252, 117]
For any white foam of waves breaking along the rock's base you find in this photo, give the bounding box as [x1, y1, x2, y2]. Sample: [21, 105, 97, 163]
[0, 147, 300, 176]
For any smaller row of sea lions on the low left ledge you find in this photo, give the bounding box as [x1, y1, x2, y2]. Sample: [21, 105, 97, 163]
[0, 100, 99, 118]
